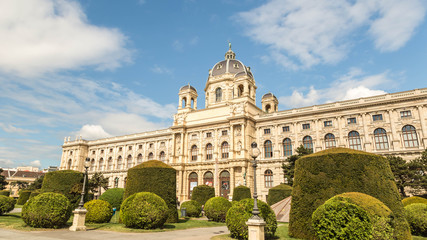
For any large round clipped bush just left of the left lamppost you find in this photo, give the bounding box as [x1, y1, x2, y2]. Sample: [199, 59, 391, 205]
[21, 193, 71, 228]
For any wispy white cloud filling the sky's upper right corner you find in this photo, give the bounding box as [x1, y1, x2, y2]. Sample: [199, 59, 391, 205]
[236, 0, 426, 69]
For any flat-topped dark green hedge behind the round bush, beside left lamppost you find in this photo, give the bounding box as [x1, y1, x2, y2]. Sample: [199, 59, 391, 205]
[41, 170, 84, 208]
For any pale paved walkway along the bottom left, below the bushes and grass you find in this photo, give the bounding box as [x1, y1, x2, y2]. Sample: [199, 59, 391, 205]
[0, 226, 230, 240]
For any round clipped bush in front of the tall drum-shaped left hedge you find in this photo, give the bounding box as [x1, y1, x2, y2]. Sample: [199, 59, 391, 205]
[120, 192, 168, 229]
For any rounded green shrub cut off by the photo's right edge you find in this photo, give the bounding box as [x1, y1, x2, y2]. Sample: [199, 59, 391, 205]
[405, 203, 427, 237]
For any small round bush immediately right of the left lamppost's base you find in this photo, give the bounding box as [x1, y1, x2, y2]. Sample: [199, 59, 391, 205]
[84, 200, 113, 223]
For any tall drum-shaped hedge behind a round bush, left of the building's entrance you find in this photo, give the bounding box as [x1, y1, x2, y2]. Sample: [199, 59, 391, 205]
[124, 160, 178, 223]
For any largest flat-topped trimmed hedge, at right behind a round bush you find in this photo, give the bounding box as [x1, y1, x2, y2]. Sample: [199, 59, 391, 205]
[289, 148, 411, 239]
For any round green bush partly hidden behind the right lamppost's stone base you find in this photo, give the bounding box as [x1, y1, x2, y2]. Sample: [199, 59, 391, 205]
[225, 198, 277, 239]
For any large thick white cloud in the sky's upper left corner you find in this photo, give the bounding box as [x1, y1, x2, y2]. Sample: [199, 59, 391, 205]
[0, 0, 131, 76]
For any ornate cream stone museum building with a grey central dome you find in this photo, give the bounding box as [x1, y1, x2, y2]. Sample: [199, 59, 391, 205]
[60, 47, 427, 202]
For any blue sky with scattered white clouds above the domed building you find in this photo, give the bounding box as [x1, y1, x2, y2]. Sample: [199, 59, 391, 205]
[0, 0, 427, 168]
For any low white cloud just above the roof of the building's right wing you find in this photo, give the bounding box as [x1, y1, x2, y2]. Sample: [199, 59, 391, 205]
[279, 69, 393, 108]
